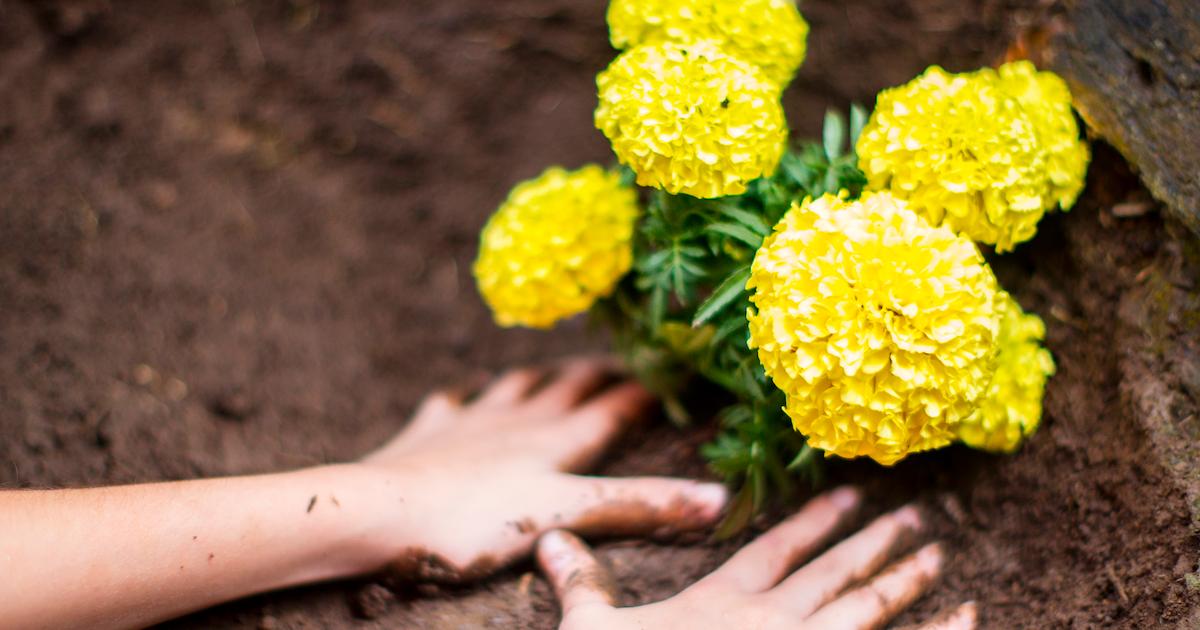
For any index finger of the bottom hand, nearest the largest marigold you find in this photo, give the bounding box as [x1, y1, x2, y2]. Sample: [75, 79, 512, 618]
[704, 487, 860, 593]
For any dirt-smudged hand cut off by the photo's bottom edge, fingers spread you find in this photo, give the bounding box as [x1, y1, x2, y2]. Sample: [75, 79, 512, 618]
[538, 488, 976, 630]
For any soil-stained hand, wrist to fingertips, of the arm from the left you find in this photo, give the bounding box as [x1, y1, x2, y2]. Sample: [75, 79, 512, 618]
[359, 360, 727, 582]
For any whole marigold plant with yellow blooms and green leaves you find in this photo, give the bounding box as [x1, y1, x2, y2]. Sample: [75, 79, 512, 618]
[475, 0, 1088, 523]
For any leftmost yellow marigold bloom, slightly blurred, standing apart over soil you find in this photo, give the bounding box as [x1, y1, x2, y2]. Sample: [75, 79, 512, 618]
[474, 164, 638, 328]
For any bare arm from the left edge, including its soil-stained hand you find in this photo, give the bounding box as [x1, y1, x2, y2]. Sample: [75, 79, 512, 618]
[0, 361, 725, 629]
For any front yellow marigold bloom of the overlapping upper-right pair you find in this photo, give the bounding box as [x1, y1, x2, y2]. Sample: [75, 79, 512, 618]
[857, 66, 1056, 252]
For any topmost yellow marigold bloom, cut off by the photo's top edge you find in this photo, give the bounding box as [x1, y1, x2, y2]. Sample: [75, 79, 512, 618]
[608, 0, 809, 86]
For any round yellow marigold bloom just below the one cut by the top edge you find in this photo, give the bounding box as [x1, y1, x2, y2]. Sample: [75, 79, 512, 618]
[595, 42, 787, 198]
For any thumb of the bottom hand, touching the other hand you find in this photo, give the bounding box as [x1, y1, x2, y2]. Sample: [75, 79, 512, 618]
[538, 529, 617, 617]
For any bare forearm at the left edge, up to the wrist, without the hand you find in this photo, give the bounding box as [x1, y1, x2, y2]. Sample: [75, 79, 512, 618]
[0, 466, 401, 629]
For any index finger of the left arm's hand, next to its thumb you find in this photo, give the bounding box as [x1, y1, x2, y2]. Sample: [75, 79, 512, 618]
[540, 380, 656, 472]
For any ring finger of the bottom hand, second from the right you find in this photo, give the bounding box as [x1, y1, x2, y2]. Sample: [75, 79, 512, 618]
[806, 544, 943, 630]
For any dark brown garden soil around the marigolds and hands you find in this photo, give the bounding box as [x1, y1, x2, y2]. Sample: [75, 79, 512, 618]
[0, 0, 1200, 629]
